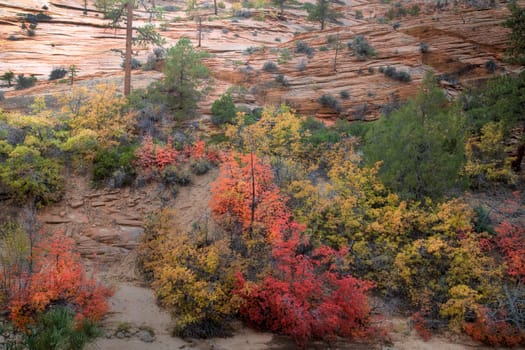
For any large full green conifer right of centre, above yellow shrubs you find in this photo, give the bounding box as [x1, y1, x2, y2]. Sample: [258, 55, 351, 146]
[365, 75, 464, 200]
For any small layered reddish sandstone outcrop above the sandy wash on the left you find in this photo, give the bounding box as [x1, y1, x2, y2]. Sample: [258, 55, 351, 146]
[38, 177, 151, 269]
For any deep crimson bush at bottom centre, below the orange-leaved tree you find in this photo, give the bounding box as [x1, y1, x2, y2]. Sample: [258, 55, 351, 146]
[235, 223, 373, 347]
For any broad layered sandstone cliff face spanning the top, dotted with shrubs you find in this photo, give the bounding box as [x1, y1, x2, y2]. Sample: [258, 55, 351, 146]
[0, 0, 525, 121]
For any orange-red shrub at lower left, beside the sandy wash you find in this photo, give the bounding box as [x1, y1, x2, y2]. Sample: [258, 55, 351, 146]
[7, 233, 113, 329]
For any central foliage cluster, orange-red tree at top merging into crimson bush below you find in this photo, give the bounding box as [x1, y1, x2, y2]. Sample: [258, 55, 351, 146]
[210, 154, 374, 347]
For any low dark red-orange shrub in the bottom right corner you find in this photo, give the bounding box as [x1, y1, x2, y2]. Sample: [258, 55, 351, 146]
[464, 308, 525, 346]
